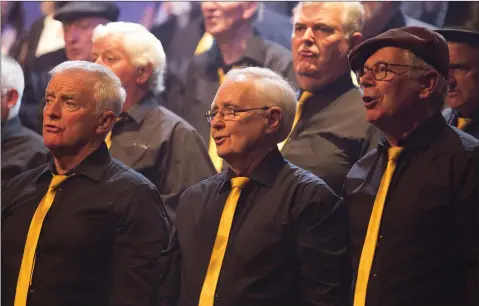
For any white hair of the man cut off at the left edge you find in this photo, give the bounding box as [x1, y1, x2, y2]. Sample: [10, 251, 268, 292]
[1, 55, 25, 120]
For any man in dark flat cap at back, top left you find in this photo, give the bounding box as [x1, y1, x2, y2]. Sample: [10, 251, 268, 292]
[20, 1, 120, 134]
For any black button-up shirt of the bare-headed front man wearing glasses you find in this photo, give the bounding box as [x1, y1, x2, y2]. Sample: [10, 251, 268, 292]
[176, 149, 351, 306]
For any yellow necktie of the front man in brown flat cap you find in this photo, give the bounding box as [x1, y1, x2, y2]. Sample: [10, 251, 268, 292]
[354, 147, 403, 306]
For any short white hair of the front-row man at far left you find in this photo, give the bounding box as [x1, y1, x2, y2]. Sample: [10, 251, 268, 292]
[50, 61, 126, 116]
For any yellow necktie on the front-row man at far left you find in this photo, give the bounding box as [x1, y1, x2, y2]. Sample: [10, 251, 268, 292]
[14, 175, 68, 306]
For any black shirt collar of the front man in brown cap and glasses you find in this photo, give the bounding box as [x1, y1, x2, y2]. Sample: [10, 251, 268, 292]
[378, 112, 447, 151]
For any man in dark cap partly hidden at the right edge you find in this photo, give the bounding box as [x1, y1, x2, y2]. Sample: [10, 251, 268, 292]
[436, 28, 479, 138]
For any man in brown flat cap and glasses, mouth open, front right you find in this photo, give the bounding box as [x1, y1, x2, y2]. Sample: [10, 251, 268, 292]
[343, 27, 479, 306]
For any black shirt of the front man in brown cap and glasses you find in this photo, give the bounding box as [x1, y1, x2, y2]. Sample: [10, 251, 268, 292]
[344, 113, 479, 306]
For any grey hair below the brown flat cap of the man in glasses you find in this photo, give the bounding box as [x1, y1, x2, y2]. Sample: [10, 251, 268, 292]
[402, 49, 449, 110]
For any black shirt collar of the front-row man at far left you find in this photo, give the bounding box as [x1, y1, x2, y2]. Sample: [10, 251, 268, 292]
[36, 142, 111, 183]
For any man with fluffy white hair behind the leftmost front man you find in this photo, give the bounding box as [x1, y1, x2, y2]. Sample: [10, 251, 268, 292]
[93, 22, 215, 220]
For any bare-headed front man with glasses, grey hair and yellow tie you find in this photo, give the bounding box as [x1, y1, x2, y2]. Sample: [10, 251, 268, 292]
[176, 67, 352, 306]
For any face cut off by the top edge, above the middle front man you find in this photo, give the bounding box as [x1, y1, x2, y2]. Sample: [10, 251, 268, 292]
[201, 1, 245, 36]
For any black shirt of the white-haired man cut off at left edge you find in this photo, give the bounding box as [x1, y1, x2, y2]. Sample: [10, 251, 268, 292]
[2, 117, 49, 189]
